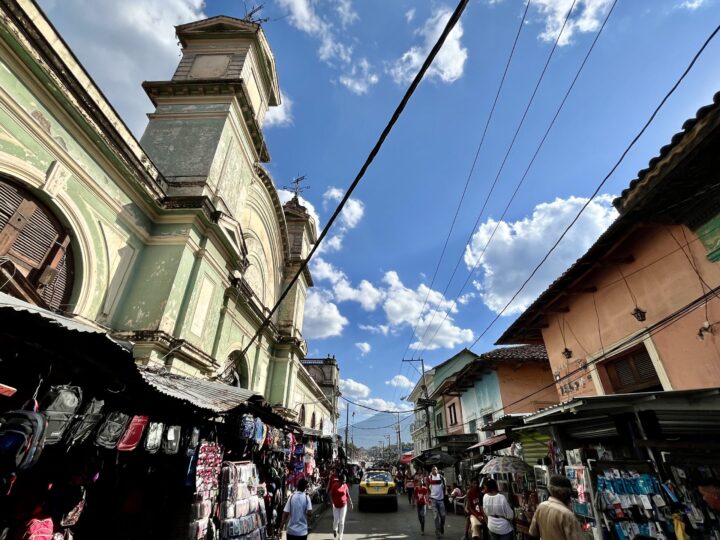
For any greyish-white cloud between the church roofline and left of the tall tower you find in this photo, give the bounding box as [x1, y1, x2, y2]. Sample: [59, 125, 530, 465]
[40, 0, 206, 137]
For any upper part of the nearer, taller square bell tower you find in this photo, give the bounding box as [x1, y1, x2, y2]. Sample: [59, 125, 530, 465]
[141, 16, 280, 215]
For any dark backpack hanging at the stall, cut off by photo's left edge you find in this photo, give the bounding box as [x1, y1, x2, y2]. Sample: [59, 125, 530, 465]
[0, 404, 47, 474]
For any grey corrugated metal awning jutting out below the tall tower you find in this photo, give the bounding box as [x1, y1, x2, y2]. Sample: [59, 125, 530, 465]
[138, 367, 260, 413]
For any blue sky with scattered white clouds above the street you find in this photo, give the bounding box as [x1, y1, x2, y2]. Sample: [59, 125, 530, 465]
[40, 0, 720, 424]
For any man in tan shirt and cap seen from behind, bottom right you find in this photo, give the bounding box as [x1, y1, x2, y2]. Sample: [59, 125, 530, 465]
[530, 475, 582, 540]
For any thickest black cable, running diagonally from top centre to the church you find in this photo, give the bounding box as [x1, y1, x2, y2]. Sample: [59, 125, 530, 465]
[226, 0, 476, 373]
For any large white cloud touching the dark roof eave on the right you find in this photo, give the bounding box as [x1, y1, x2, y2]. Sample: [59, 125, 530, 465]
[465, 195, 617, 315]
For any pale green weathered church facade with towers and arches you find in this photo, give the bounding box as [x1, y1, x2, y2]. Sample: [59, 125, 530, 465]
[0, 1, 336, 425]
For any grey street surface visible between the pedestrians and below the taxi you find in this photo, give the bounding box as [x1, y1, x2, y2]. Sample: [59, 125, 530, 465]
[309, 486, 465, 540]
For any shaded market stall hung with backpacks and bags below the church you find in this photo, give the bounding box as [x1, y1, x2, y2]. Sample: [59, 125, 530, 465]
[0, 295, 306, 540]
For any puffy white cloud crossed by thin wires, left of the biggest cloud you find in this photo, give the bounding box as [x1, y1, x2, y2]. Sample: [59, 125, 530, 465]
[383, 271, 473, 350]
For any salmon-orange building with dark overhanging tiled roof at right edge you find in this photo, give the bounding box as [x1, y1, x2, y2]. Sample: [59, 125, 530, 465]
[498, 93, 720, 401]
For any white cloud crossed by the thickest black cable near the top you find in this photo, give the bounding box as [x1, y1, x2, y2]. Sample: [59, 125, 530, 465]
[388, 7, 468, 84]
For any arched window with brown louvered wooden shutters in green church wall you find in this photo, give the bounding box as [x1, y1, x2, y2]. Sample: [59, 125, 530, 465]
[0, 177, 73, 309]
